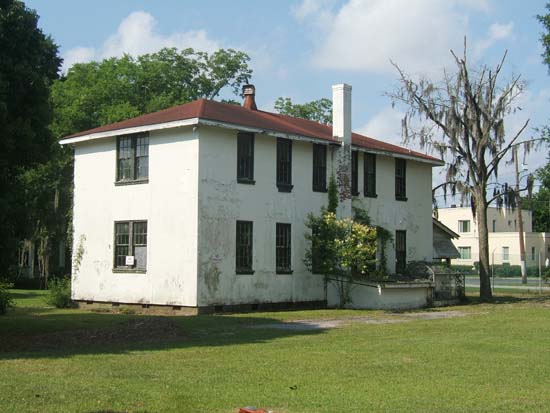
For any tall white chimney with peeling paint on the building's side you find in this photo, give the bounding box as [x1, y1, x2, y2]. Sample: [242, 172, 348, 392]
[332, 83, 352, 218]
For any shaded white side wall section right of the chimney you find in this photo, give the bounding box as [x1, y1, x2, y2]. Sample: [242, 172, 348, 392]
[353, 153, 433, 272]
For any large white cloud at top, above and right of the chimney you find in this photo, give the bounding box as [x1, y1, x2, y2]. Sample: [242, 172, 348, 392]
[293, 0, 504, 74]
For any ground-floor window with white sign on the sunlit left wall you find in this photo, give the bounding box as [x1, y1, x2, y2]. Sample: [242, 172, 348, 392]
[114, 221, 147, 271]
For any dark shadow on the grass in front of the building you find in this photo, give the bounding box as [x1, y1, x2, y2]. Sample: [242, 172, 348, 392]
[0, 308, 324, 360]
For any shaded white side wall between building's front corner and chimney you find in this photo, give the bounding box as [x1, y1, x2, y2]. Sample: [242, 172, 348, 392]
[198, 127, 332, 306]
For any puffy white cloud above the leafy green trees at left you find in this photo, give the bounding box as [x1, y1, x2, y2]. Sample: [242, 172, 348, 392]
[62, 11, 220, 71]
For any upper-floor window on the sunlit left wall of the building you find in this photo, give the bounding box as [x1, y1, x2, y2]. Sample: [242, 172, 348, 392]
[116, 134, 149, 182]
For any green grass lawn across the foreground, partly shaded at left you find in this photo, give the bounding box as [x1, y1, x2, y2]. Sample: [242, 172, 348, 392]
[0, 291, 550, 413]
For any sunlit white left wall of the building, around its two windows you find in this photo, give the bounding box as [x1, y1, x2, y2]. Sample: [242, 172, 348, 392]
[72, 128, 199, 306]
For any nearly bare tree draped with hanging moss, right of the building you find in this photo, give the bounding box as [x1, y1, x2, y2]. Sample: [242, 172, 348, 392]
[389, 42, 533, 299]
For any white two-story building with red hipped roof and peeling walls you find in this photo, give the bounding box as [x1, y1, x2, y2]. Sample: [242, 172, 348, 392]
[61, 85, 442, 309]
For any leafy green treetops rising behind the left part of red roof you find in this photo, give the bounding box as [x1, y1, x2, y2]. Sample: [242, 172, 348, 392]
[52, 48, 252, 137]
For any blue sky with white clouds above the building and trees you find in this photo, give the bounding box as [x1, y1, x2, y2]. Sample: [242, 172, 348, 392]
[25, 0, 550, 202]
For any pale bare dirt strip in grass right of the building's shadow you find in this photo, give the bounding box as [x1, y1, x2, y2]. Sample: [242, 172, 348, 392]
[251, 311, 471, 330]
